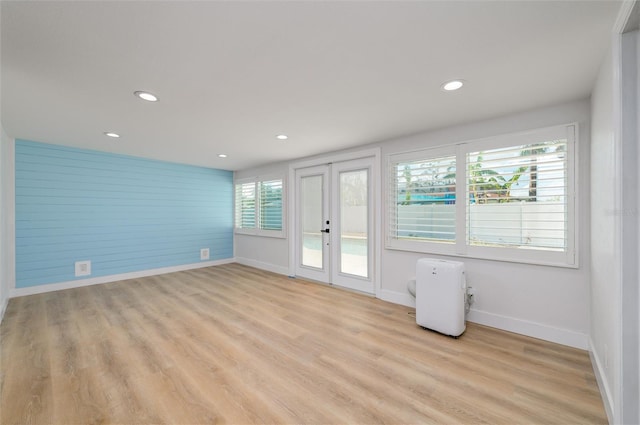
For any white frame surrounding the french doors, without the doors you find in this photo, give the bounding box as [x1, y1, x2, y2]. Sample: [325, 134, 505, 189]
[288, 148, 383, 298]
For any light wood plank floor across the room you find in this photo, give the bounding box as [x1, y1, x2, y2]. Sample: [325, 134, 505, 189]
[0, 264, 606, 425]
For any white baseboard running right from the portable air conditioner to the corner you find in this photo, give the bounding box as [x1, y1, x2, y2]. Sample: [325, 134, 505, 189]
[467, 309, 589, 350]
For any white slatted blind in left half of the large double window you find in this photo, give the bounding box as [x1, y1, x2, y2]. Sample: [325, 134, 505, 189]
[389, 154, 456, 244]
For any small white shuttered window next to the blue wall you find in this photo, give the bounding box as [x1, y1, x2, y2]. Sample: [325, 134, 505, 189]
[235, 174, 284, 237]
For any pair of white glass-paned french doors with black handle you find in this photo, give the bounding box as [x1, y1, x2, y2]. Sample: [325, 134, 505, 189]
[295, 158, 375, 294]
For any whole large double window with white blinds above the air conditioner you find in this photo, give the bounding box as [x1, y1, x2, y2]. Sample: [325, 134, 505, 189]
[387, 125, 577, 266]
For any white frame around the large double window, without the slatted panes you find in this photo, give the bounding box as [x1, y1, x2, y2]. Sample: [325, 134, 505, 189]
[385, 123, 579, 268]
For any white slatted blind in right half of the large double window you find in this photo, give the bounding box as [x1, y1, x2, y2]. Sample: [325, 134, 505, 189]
[466, 139, 568, 251]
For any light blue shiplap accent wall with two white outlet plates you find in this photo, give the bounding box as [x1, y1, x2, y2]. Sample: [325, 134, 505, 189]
[15, 140, 233, 288]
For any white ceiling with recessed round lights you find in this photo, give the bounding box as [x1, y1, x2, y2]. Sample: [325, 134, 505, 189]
[1, 1, 620, 170]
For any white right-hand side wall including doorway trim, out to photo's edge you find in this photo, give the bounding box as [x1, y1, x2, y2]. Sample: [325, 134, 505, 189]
[590, 18, 640, 424]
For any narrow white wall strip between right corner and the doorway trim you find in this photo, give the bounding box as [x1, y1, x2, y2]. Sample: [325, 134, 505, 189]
[590, 43, 620, 418]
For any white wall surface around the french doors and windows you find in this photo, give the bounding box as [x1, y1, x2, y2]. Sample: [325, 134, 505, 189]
[235, 101, 590, 348]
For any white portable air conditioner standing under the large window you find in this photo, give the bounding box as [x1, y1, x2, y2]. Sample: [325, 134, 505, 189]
[416, 258, 467, 337]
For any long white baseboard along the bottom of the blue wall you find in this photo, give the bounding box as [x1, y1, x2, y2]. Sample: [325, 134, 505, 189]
[9, 258, 234, 298]
